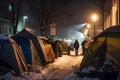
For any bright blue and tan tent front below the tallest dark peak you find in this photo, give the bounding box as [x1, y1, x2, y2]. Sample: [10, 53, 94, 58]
[12, 36, 41, 65]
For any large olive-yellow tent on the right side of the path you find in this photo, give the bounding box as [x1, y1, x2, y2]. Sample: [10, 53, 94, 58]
[76, 26, 120, 80]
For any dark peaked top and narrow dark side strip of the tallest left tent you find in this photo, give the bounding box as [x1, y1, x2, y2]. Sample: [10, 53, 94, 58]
[15, 28, 47, 65]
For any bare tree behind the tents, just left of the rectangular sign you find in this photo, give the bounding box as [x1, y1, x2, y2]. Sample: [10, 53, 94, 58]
[30, 0, 54, 36]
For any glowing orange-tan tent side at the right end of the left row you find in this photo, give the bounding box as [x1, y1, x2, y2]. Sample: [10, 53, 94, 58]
[38, 36, 55, 63]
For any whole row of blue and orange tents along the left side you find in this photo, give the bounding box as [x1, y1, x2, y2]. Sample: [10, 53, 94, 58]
[0, 28, 55, 73]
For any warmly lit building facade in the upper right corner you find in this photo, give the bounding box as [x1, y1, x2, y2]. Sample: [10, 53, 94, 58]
[104, 0, 120, 29]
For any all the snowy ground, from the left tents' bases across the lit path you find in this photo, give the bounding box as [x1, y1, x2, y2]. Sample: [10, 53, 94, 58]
[0, 50, 103, 80]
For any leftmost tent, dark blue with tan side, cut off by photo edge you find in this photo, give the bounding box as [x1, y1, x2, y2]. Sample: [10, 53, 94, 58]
[0, 34, 27, 73]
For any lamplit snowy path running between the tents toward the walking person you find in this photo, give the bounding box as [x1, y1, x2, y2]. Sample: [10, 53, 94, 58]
[41, 50, 83, 80]
